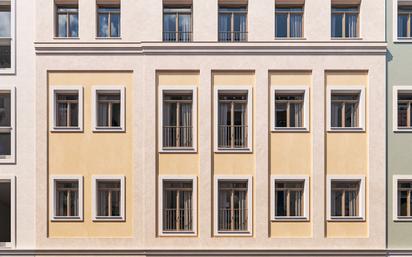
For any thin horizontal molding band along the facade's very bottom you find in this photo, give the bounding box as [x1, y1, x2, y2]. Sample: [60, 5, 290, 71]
[0, 249, 392, 257]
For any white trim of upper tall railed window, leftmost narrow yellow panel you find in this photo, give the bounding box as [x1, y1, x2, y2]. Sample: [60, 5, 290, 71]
[158, 85, 197, 153]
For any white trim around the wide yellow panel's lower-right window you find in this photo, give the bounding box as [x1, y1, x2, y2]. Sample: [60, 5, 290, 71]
[92, 176, 126, 221]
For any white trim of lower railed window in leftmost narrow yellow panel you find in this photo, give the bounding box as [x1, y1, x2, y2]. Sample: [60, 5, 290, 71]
[158, 176, 197, 236]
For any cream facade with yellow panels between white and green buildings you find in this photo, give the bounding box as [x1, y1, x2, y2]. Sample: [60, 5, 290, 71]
[2, 0, 389, 256]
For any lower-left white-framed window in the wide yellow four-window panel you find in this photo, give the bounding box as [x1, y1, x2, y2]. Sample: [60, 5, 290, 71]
[51, 176, 83, 221]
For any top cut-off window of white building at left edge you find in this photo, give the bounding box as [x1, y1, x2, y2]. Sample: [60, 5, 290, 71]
[0, 0, 14, 73]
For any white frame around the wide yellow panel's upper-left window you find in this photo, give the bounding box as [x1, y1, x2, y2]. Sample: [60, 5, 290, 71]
[49, 86, 83, 132]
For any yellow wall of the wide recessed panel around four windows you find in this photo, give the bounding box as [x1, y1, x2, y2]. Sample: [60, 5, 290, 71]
[48, 72, 135, 238]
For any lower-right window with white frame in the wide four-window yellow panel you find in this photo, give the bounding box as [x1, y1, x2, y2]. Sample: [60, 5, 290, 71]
[93, 177, 125, 220]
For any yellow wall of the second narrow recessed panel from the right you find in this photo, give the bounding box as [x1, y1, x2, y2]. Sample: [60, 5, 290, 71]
[269, 71, 313, 238]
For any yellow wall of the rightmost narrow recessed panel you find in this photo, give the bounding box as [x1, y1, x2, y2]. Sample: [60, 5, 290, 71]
[325, 71, 370, 237]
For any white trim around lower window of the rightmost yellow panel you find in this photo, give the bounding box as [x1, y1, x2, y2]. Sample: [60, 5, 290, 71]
[326, 176, 366, 221]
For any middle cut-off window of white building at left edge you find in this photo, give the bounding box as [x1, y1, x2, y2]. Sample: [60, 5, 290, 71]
[0, 88, 16, 163]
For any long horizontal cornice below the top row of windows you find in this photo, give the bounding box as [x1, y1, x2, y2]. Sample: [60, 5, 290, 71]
[35, 41, 387, 55]
